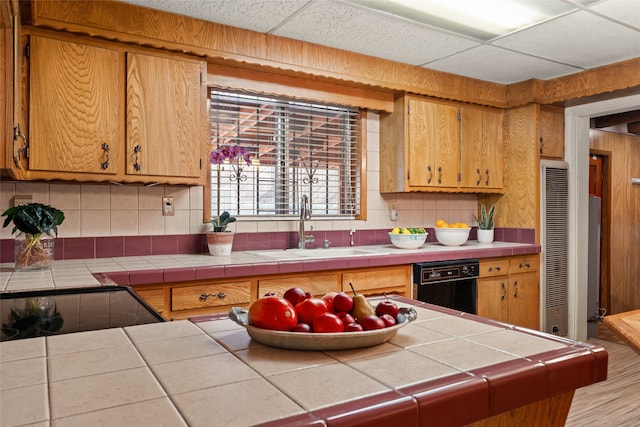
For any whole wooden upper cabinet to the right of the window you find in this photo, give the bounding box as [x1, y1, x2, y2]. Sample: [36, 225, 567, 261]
[380, 95, 504, 193]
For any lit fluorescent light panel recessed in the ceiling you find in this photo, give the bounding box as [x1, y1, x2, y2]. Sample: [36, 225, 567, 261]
[349, 0, 576, 41]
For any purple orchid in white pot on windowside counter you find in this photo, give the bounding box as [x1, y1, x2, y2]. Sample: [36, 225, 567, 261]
[207, 145, 251, 255]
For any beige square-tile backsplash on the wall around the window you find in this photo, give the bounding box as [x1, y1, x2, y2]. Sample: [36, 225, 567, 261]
[0, 113, 477, 238]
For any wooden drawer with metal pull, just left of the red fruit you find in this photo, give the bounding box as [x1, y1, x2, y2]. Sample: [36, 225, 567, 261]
[171, 280, 251, 311]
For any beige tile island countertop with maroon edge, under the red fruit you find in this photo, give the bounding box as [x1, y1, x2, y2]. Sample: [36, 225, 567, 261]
[0, 297, 608, 427]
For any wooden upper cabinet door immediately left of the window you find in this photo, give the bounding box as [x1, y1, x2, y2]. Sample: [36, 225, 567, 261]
[126, 53, 208, 178]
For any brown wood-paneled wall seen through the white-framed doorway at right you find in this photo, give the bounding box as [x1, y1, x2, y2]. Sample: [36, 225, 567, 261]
[589, 129, 640, 314]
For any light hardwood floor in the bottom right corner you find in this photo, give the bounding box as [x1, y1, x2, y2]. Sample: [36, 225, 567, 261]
[566, 326, 640, 427]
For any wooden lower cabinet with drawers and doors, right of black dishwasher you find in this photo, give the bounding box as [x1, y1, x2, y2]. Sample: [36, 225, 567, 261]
[477, 255, 540, 330]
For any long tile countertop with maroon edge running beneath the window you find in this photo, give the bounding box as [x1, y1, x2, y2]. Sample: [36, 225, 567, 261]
[0, 240, 540, 292]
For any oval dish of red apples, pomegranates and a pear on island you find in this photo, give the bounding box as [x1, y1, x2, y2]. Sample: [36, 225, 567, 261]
[229, 287, 417, 351]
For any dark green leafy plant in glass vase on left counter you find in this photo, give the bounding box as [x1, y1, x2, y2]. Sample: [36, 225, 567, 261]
[2, 203, 64, 271]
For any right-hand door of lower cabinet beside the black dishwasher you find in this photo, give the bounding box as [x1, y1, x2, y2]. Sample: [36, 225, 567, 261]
[509, 272, 540, 330]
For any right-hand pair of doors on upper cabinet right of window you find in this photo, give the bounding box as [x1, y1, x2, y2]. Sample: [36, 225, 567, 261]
[460, 107, 504, 190]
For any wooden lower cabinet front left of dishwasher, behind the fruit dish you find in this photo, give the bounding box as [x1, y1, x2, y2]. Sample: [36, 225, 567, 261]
[133, 265, 411, 320]
